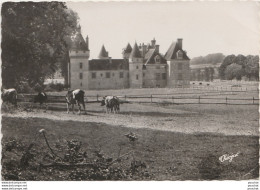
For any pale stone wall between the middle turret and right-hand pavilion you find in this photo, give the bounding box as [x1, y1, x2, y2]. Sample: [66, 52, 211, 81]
[143, 64, 167, 88]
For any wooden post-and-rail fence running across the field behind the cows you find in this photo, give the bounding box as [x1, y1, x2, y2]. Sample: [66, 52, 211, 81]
[18, 92, 259, 105]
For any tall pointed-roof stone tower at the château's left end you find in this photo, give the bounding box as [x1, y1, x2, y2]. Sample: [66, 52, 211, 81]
[68, 31, 89, 89]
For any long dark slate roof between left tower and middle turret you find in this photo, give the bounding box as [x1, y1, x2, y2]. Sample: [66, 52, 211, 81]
[89, 59, 129, 71]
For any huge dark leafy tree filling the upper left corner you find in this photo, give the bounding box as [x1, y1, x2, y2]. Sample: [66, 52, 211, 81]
[1, 2, 78, 88]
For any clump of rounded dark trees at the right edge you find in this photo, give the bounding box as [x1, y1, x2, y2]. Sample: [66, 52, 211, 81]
[219, 54, 259, 80]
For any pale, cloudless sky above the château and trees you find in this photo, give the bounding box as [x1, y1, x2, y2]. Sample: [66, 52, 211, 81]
[67, 1, 260, 59]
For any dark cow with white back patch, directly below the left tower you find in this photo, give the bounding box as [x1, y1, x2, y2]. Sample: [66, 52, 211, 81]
[66, 89, 86, 114]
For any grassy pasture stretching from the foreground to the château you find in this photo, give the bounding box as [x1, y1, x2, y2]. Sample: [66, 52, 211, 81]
[2, 83, 259, 180]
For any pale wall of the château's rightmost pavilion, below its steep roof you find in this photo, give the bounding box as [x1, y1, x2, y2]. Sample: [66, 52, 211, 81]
[167, 60, 190, 88]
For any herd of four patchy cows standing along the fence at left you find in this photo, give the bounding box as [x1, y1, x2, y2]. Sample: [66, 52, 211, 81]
[1, 88, 120, 113]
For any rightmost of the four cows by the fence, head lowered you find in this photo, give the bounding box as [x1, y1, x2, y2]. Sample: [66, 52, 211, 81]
[101, 96, 120, 113]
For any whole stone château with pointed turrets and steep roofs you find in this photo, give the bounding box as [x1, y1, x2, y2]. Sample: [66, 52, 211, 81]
[68, 33, 190, 90]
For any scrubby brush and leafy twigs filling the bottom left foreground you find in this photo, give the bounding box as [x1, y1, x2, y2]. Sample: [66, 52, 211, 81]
[2, 139, 150, 181]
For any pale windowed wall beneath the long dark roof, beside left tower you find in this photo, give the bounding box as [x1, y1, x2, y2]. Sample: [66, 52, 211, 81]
[88, 70, 129, 90]
